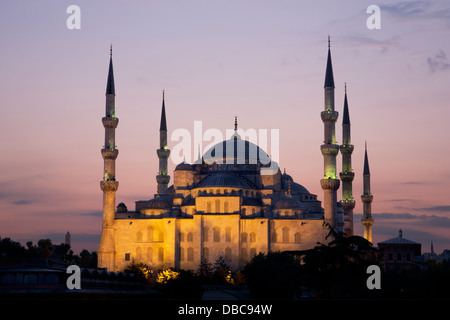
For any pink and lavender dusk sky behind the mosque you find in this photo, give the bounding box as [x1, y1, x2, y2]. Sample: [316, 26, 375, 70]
[0, 0, 450, 254]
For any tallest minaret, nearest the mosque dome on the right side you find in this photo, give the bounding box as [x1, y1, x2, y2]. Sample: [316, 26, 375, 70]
[320, 36, 340, 231]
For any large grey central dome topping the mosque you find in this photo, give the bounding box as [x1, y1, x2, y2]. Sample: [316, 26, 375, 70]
[203, 135, 271, 165]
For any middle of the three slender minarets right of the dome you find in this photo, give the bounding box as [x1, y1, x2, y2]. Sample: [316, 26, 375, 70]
[339, 84, 355, 236]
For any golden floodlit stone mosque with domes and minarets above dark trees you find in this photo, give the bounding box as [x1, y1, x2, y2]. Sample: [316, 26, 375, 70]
[99, 42, 370, 271]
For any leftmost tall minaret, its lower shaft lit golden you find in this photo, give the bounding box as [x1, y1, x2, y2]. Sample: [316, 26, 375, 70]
[98, 46, 119, 271]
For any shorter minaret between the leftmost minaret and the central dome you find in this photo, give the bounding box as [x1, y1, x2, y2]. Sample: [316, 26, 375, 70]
[156, 90, 170, 195]
